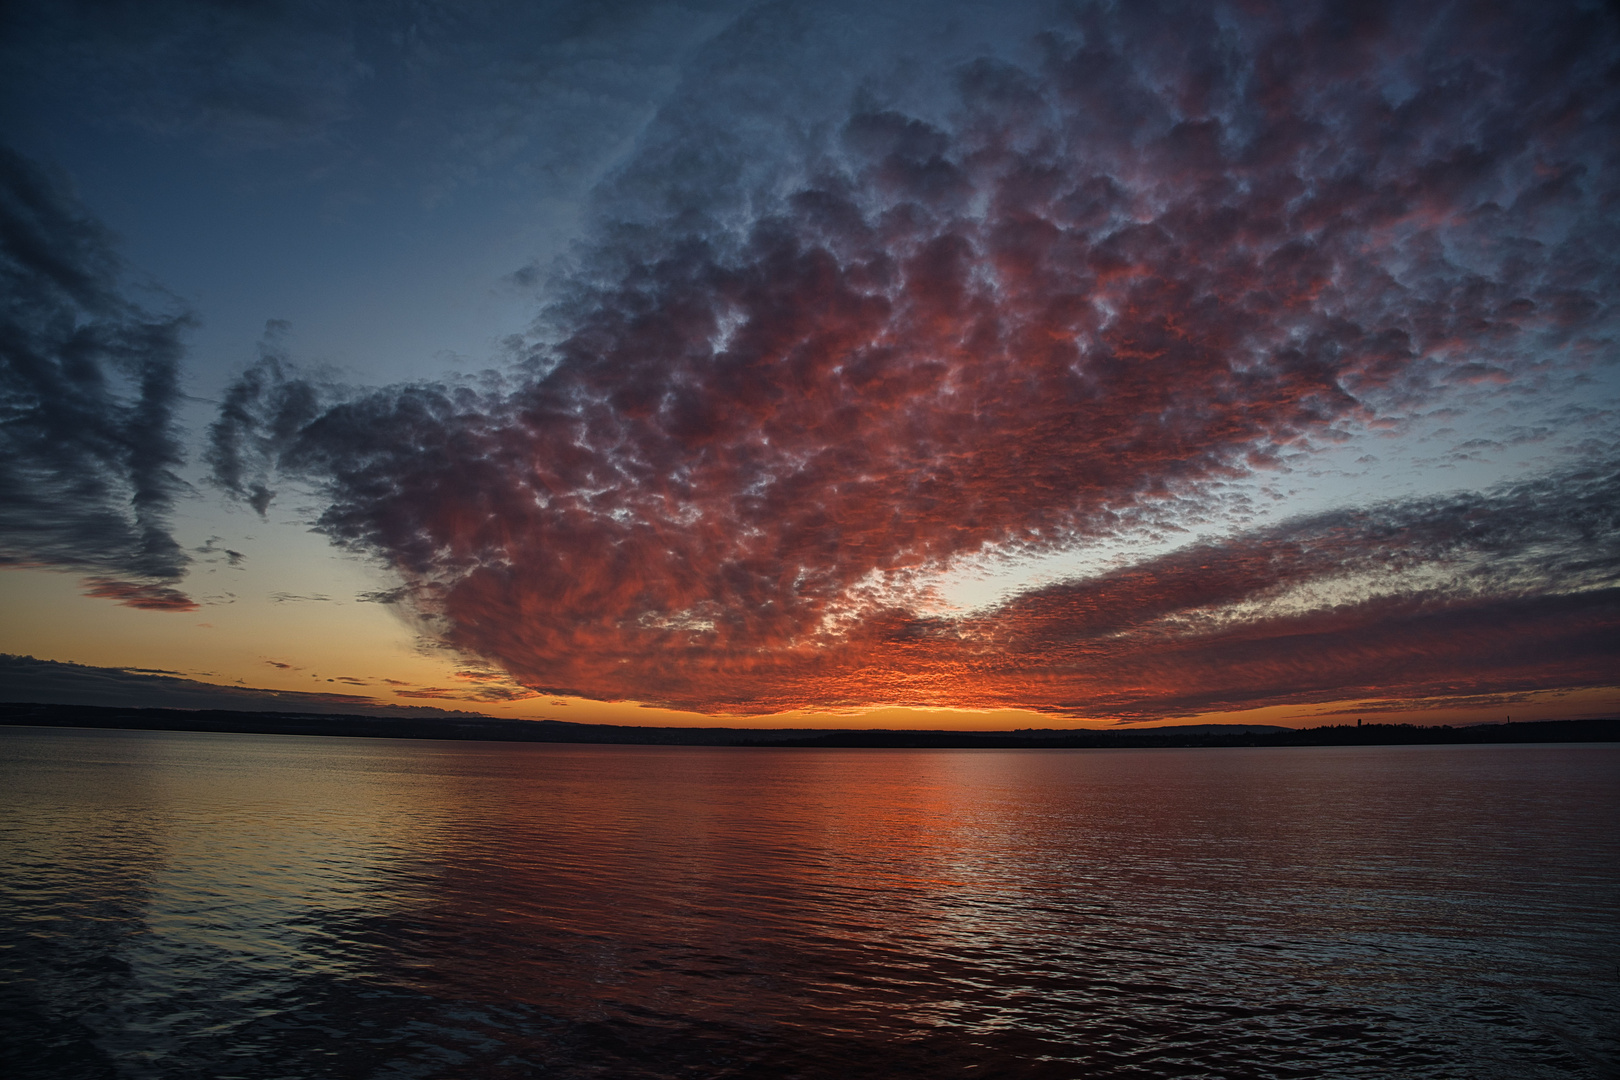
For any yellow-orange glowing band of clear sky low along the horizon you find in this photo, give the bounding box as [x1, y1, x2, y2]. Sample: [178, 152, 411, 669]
[0, 570, 1620, 730]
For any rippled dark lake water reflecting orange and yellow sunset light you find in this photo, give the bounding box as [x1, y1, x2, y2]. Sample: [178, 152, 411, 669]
[0, 729, 1620, 1080]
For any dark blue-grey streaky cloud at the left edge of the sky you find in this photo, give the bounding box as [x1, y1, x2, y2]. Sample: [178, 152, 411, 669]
[0, 147, 194, 610]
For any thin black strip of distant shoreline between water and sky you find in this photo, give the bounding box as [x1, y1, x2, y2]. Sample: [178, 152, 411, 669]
[0, 703, 1620, 750]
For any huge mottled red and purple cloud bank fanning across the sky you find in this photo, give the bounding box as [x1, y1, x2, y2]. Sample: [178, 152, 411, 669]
[211, 3, 1620, 717]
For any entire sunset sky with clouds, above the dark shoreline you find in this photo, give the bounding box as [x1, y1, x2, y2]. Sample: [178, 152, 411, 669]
[0, 0, 1620, 729]
